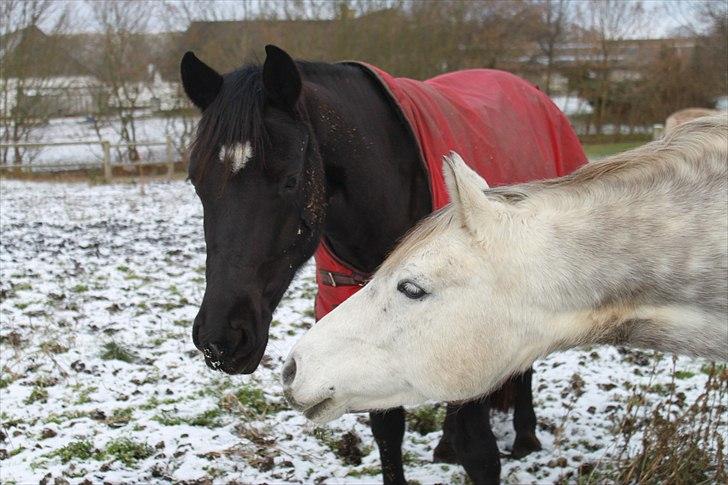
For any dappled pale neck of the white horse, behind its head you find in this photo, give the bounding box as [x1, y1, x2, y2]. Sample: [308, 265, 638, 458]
[512, 156, 728, 357]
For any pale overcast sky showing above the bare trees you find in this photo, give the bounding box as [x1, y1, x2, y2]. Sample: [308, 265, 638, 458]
[45, 0, 712, 38]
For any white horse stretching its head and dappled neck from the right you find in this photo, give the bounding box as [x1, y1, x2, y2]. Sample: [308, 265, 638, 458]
[283, 115, 728, 422]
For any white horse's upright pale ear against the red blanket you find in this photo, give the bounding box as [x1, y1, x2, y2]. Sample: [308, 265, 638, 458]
[442, 152, 502, 238]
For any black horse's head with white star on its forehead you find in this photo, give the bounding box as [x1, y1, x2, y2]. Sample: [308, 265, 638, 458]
[181, 46, 325, 374]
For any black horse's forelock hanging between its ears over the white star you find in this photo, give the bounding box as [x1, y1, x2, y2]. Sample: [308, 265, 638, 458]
[189, 64, 268, 182]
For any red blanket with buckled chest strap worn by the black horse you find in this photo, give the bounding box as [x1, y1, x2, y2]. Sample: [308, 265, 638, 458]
[315, 64, 586, 319]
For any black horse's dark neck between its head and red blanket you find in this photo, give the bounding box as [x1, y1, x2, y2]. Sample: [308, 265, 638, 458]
[302, 65, 431, 272]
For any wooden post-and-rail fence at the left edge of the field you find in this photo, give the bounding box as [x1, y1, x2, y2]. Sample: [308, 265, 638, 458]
[0, 137, 174, 182]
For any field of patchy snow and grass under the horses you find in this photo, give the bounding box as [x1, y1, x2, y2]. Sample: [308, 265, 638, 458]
[0, 180, 725, 484]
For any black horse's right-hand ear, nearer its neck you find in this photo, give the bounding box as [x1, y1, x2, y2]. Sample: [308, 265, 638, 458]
[263, 45, 301, 111]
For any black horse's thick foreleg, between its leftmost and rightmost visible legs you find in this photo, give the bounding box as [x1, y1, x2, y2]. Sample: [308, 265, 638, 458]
[444, 398, 500, 485]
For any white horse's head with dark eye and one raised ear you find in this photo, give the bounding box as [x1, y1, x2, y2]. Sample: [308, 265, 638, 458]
[283, 153, 539, 422]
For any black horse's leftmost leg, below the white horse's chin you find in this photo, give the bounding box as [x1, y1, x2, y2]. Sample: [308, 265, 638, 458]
[369, 408, 407, 485]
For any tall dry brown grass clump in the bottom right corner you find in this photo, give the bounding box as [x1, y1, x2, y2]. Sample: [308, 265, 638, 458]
[577, 361, 728, 484]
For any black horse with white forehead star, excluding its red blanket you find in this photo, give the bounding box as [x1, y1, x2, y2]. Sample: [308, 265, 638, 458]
[181, 46, 540, 483]
